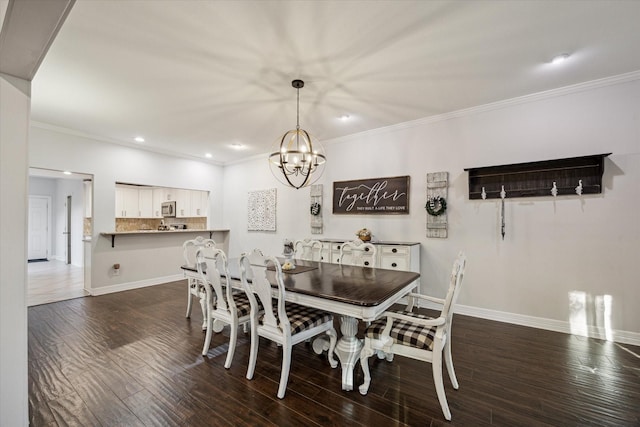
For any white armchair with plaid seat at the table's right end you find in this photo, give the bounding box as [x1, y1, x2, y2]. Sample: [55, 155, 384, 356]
[360, 252, 467, 420]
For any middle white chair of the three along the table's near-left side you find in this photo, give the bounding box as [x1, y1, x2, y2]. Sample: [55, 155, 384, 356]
[196, 246, 260, 369]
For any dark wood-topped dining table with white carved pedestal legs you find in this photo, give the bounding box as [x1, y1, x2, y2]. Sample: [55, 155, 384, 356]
[181, 259, 420, 390]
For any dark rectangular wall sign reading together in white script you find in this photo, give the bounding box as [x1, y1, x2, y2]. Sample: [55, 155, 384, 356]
[333, 176, 409, 215]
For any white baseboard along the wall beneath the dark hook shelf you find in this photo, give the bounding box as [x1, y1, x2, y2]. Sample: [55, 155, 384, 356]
[422, 303, 640, 345]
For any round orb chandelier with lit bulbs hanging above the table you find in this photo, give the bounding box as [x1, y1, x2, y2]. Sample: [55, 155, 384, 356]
[269, 80, 327, 189]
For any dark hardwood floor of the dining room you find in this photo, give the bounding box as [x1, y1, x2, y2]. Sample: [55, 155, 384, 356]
[29, 281, 640, 426]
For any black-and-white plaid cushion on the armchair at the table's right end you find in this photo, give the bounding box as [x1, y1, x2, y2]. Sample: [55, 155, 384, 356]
[365, 310, 436, 350]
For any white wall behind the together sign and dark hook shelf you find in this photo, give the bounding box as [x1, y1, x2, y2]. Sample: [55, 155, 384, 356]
[223, 75, 640, 343]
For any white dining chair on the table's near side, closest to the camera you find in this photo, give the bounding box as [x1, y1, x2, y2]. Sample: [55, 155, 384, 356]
[240, 249, 338, 399]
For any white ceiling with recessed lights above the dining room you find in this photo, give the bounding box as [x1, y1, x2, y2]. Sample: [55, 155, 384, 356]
[20, 0, 640, 164]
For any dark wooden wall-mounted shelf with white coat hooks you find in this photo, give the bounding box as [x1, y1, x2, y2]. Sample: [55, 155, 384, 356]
[465, 153, 611, 200]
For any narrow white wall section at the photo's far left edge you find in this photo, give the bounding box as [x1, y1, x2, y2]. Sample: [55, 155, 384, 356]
[0, 74, 31, 426]
